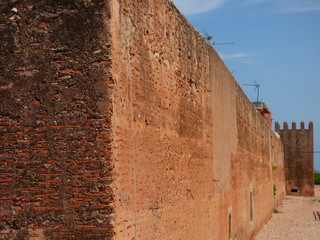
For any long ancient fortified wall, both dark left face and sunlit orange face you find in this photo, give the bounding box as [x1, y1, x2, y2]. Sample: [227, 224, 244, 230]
[0, 0, 285, 240]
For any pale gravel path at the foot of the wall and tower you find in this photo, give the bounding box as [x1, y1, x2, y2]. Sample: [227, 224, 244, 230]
[255, 187, 320, 240]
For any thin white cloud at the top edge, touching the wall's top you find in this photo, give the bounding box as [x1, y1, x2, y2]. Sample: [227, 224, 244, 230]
[173, 0, 229, 15]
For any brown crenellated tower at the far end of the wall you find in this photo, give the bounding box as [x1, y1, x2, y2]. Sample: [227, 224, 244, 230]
[275, 122, 314, 196]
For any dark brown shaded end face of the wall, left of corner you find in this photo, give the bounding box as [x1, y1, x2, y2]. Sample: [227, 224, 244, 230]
[0, 0, 113, 239]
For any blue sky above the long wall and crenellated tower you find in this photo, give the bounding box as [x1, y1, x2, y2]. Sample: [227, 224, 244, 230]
[173, 0, 320, 170]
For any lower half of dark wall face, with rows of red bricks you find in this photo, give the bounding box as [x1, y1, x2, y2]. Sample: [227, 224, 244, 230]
[0, 119, 113, 239]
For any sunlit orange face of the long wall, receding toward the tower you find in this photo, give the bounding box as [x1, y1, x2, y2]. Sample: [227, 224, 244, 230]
[111, 0, 284, 240]
